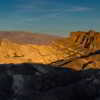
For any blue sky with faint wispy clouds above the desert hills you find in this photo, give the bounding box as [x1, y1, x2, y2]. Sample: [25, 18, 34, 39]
[0, 0, 100, 35]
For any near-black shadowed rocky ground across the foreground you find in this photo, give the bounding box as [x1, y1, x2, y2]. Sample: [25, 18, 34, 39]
[0, 64, 100, 100]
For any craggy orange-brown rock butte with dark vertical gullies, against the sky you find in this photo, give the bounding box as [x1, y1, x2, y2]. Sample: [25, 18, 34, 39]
[71, 30, 98, 49]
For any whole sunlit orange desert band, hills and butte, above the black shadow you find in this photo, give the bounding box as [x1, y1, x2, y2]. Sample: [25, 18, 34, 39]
[0, 30, 100, 70]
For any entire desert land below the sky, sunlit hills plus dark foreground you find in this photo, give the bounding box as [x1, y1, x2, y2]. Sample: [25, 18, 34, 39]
[0, 30, 100, 100]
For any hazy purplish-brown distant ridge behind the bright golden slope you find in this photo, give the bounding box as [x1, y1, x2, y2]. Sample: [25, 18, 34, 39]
[0, 31, 60, 44]
